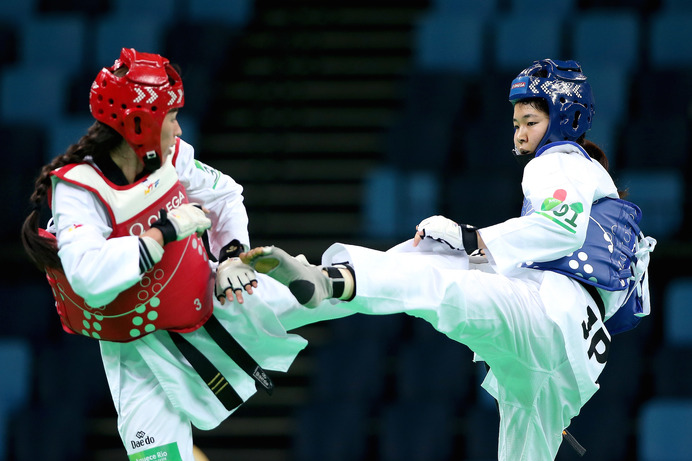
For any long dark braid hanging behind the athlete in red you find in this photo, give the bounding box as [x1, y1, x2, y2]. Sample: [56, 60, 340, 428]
[21, 121, 123, 270]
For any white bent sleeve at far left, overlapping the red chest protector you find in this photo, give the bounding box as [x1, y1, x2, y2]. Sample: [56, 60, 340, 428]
[52, 181, 140, 307]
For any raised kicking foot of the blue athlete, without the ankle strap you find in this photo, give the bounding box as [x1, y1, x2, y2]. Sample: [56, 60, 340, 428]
[240, 246, 333, 307]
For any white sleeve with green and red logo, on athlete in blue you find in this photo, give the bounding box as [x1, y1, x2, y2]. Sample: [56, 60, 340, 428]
[479, 151, 604, 274]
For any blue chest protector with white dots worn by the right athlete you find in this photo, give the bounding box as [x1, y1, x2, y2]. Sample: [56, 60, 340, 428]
[522, 192, 656, 334]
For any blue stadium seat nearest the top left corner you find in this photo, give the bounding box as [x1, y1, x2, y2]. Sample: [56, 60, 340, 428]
[19, 14, 87, 69]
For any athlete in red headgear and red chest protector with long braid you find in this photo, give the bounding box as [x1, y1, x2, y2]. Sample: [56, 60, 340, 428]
[22, 49, 347, 461]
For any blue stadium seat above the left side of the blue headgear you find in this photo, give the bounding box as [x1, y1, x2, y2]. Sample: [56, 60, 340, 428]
[492, 11, 563, 73]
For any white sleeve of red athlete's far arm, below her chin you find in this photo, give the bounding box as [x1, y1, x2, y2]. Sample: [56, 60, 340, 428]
[175, 140, 250, 256]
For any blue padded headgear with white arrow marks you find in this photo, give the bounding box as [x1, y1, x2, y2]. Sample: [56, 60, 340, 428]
[509, 59, 595, 164]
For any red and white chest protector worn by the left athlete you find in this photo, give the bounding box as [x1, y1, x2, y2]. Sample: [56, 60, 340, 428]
[43, 148, 214, 342]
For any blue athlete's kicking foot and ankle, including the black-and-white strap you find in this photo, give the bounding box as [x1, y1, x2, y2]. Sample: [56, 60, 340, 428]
[240, 246, 355, 307]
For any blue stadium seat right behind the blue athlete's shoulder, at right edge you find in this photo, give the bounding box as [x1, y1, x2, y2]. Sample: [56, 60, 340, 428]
[618, 168, 684, 241]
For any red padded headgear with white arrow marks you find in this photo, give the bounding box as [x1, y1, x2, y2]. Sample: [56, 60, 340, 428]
[89, 48, 185, 168]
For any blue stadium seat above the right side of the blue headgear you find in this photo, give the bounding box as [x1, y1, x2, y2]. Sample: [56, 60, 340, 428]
[570, 9, 642, 71]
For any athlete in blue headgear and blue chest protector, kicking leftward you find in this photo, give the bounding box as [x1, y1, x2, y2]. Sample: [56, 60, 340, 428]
[241, 59, 655, 461]
